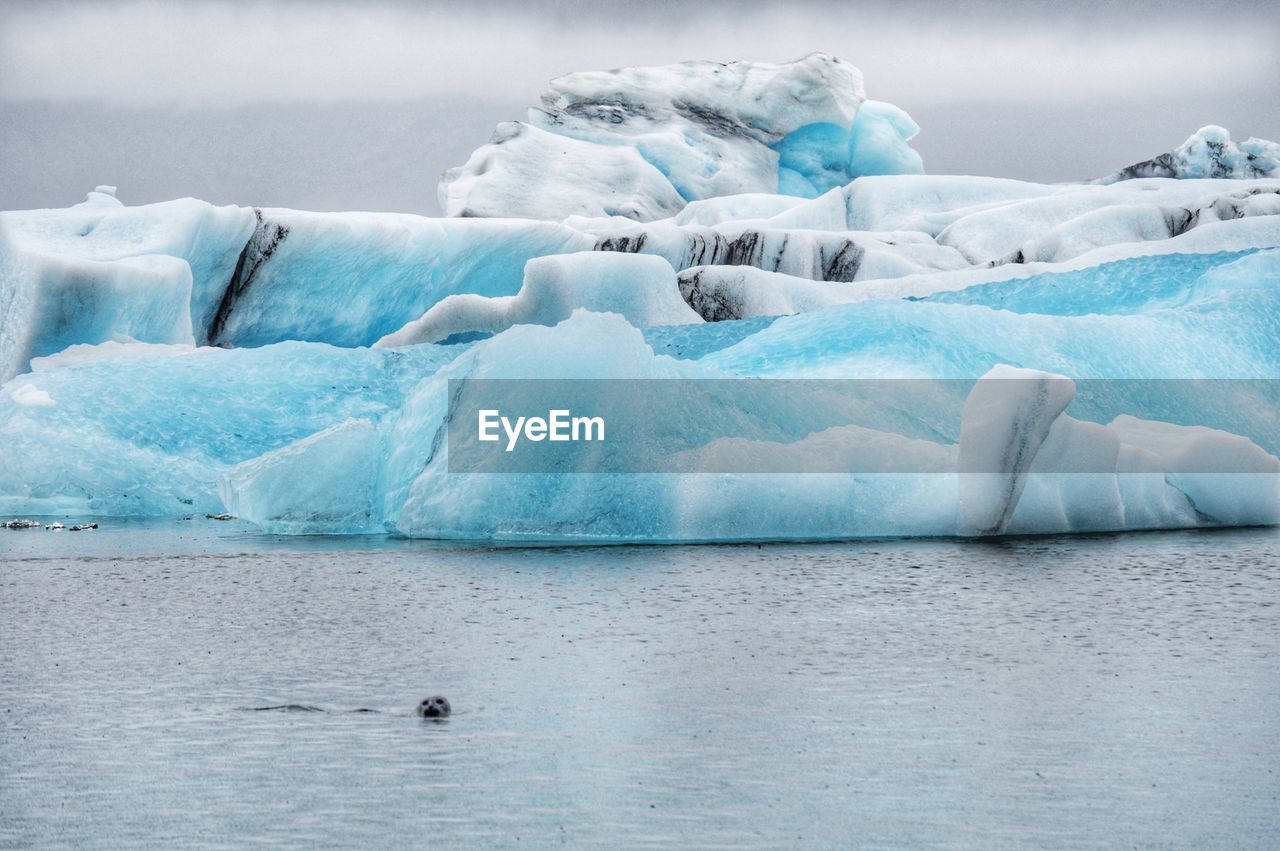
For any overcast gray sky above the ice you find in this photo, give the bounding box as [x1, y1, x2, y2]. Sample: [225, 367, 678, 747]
[0, 0, 1280, 214]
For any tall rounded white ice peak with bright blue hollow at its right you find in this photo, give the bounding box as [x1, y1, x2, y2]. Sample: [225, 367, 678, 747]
[439, 54, 924, 221]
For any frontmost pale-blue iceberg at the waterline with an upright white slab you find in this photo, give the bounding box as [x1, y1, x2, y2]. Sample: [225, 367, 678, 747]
[221, 311, 1280, 541]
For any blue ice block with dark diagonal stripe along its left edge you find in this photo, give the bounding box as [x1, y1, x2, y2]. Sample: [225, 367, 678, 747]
[206, 210, 594, 346]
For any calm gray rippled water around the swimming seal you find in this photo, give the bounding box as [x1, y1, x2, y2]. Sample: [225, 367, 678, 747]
[0, 521, 1280, 847]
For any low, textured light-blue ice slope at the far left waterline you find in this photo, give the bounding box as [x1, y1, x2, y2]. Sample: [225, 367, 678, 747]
[0, 343, 460, 516]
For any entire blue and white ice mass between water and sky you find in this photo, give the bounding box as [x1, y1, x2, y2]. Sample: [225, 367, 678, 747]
[0, 55, 1280, 541]
